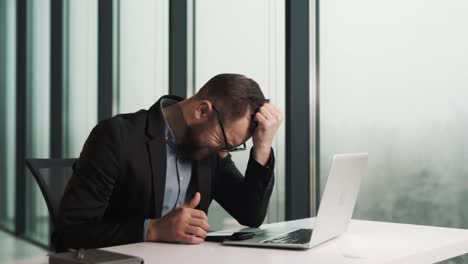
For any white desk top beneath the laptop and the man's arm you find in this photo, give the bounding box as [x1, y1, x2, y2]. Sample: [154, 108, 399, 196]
[3, 218, 468, 264]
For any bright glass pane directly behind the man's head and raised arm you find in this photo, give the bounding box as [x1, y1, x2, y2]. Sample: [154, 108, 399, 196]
[193, 0, 285, 229]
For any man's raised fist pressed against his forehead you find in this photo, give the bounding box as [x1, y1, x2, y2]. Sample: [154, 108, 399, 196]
[252, 102, 283, 166]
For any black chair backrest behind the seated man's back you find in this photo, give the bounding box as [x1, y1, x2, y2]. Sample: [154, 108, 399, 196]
[25, 159, 76, 235]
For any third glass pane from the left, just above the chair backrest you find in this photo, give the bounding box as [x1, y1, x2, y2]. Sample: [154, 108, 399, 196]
[63, 0, 98, 158]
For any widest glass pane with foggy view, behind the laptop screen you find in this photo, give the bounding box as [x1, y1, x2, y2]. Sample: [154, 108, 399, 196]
[320, 0, 468, 260]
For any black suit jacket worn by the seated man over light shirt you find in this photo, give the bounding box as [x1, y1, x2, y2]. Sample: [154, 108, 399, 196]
[52, 96, 274, 251]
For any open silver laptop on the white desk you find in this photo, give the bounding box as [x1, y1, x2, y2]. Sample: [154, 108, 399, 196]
[223, 153, 368, 249]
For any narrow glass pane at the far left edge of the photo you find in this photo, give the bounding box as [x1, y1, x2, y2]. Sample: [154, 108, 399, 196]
[0, 0, 16, 231]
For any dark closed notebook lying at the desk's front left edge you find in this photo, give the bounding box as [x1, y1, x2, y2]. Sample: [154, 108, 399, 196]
[49, 249, 144, 264]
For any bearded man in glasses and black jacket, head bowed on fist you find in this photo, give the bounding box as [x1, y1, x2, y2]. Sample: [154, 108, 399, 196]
[52, 74, 283, 251]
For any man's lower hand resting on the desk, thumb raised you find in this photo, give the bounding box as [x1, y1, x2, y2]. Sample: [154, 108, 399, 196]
[146, 192, 209, 244]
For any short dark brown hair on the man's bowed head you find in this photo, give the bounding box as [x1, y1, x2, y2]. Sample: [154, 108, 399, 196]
[195, 73, 265, 120]
